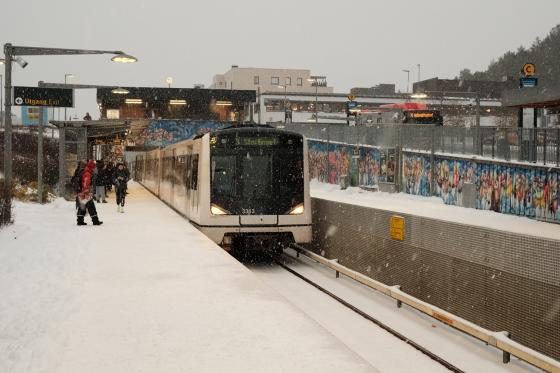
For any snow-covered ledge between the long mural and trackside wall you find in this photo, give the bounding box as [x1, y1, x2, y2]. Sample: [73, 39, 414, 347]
[311, 180, 560, 240]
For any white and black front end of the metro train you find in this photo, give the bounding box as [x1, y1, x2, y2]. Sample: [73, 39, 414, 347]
[208, 127, 311, 251]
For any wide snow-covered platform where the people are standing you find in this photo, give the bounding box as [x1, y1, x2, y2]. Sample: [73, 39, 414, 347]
[0, 183, 376, 373]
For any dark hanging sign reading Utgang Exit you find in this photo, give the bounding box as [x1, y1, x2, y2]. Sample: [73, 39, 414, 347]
[13, 87, 74, 107]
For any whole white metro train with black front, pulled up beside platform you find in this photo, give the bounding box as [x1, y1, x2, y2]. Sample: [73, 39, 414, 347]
[133, 125, 311, 253]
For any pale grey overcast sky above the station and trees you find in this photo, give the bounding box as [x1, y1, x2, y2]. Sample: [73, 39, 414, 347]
[0, 0, 560, 118]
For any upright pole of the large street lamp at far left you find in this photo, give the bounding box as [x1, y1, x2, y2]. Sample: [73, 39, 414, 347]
[4, 43, 12, 209]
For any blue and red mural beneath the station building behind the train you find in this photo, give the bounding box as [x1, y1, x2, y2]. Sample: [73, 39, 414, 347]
[134, 120, 231, 146]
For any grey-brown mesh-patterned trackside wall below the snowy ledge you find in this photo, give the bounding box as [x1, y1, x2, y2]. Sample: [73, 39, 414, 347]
[311, 198, 560, 359]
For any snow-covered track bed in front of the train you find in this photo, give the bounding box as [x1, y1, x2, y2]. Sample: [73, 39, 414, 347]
[249, 250, 541, 373]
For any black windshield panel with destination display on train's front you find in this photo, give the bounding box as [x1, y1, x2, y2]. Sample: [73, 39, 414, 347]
[211, 134, 304, 215]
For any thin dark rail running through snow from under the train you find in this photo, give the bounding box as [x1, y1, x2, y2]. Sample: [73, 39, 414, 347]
[269, 248, 464, 373]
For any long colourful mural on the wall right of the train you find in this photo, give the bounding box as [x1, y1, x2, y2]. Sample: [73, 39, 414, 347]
[308, 140, 560, 222]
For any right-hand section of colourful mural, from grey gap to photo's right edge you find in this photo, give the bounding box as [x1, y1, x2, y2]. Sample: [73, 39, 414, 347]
[403, 154, 560, 221]
